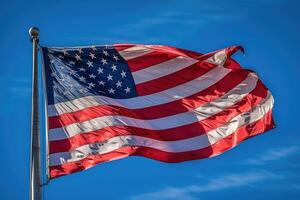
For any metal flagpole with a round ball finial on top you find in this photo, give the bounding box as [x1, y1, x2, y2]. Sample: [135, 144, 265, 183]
[29, 27, 42, 200]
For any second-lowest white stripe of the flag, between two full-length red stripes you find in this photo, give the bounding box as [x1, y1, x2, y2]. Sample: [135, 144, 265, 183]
[49, 73, 258, 141]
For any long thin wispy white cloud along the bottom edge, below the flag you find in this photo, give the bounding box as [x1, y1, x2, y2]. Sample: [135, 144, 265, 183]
[131, 171, 281, 200]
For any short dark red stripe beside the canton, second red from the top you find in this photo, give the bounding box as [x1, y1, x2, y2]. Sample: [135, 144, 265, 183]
[127, 51, 178, 72]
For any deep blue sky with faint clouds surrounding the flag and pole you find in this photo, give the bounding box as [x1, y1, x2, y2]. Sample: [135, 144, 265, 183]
[0, 0, 300, 200]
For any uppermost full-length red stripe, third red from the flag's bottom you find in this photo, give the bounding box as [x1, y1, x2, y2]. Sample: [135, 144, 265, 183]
[48, 70, 249, 129]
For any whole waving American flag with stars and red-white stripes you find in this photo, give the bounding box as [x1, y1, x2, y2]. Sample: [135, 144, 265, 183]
[42, 44, 274, 178]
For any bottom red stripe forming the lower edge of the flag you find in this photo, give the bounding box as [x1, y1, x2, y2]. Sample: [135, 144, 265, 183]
[50, 111, 275, 179]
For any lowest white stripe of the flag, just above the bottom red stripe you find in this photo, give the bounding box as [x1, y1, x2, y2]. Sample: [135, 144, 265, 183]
[50, 93, 274, 166]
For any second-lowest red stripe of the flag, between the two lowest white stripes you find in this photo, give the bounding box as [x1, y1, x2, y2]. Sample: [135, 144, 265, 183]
[49, 79, 268, 154]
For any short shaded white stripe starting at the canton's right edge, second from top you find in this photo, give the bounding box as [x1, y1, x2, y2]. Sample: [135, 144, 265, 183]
[132, 56, 198, 84]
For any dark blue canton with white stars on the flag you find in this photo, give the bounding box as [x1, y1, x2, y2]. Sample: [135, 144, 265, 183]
[42, 46, 137, 104]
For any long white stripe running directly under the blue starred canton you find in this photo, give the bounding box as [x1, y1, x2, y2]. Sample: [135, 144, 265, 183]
[48, 66, 231, 116]
